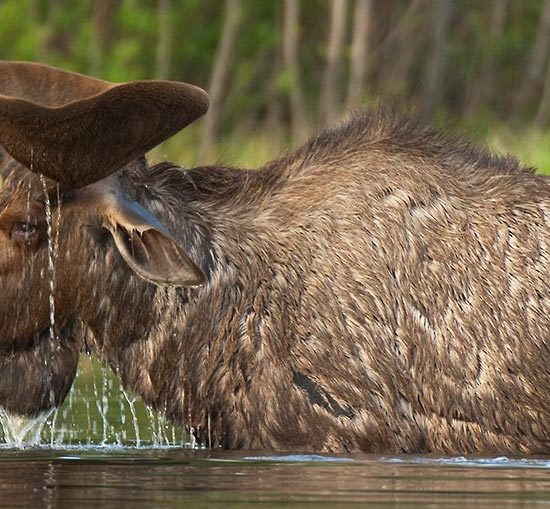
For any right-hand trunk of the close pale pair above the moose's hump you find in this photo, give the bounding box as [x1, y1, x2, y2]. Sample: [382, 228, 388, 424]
[347, 0, 372, 109]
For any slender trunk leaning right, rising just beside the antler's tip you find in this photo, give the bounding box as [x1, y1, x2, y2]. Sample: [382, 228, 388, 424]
[199, 0, 241, 160]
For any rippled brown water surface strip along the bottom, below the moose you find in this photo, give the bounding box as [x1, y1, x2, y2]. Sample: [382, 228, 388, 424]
[0, 446, 550, 508]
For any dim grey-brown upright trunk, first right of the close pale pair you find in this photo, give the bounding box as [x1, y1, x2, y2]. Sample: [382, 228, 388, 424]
[423, 0, 452, 118]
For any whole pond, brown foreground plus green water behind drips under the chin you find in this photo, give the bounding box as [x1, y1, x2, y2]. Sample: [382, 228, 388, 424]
[0, 359, 550, 508]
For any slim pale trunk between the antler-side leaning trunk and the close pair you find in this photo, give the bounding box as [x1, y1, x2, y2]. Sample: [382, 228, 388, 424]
[283, 0, 308, 143]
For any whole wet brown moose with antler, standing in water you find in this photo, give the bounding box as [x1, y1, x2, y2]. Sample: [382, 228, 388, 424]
[0, 62, 550, 454]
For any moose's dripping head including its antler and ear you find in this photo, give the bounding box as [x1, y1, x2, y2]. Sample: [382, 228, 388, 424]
[0, 62, 208, 415]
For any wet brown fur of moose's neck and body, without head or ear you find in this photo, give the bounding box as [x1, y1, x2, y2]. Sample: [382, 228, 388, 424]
[74, 113, 550, 453]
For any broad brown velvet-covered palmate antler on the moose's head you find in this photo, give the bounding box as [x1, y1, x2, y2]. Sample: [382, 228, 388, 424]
[0, 61, 209, 190]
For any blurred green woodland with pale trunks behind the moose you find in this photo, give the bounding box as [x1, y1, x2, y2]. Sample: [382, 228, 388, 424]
[0, 0, 550, 171]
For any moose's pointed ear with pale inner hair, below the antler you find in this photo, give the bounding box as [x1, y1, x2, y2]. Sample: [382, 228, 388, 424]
[106, 197, 206, 286]
